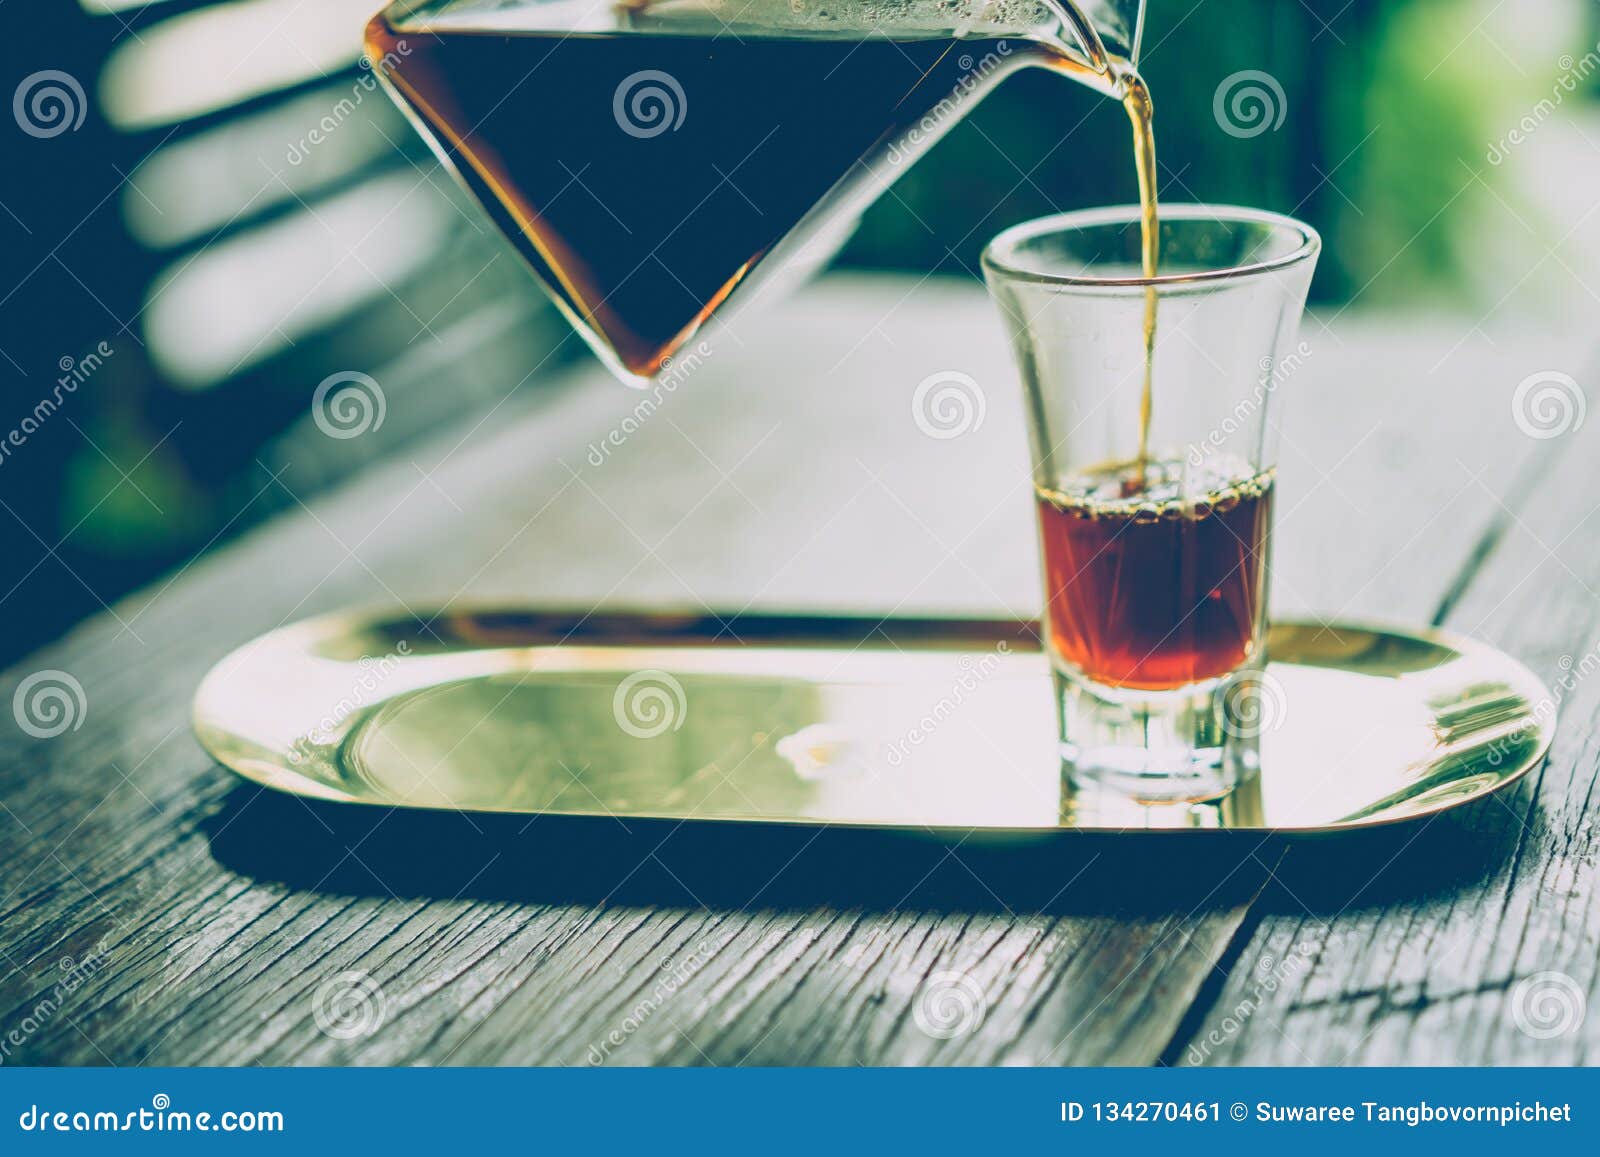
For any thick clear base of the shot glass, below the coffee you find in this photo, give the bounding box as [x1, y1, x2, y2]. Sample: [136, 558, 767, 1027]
[1054, 671, 1261, 803]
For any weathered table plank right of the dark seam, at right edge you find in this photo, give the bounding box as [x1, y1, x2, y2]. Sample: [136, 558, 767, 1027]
[1168, 360, 1600, 1064]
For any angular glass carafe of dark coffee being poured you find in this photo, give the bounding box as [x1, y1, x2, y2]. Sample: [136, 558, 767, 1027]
[366, 0, 1142, 382]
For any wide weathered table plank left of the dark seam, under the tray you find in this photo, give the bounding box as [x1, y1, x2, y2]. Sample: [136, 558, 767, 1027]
[0, 280, 1568, 1064]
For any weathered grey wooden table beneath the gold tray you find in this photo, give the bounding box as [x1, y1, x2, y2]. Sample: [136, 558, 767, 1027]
[0, 278, 1600, 1064]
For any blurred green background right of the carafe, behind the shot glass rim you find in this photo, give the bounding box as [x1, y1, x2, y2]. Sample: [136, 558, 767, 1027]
[845, 0, 1600, 309]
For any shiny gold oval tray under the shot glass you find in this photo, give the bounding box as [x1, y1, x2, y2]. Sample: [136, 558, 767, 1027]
[195, 610, 1555, 832]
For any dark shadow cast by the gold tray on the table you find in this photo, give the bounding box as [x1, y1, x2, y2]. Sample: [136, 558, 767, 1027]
[208, 786, 1515, 917]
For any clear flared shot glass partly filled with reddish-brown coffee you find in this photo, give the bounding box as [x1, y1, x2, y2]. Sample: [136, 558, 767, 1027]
[982, 205, 1320, 802]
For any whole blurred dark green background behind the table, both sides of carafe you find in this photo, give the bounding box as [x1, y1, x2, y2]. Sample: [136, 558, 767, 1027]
[0, 0, 1600, 658]
